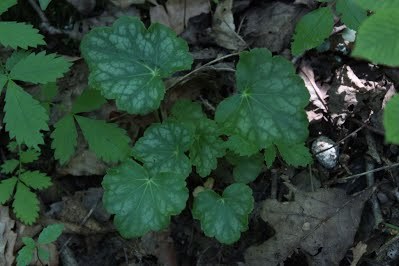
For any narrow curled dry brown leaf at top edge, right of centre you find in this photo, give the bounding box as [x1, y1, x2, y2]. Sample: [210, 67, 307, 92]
[212, 0, 247, 51]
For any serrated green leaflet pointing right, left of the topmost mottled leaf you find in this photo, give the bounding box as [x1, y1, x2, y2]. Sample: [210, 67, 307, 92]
[10, 52, 71, 84]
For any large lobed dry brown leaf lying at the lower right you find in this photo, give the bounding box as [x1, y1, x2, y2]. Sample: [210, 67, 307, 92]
[245, 185, 373, 266]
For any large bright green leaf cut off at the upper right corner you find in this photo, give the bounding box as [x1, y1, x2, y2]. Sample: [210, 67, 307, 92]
[352, 8, 399, 67]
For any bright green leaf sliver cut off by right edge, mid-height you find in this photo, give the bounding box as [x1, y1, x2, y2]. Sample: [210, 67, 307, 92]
[383, 95, 399, 144]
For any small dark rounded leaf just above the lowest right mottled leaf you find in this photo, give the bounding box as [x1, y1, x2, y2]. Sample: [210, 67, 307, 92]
[233, 153, 264, 184]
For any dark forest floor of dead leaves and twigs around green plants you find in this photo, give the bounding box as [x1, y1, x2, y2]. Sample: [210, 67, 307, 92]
[0, 0, 399, 266]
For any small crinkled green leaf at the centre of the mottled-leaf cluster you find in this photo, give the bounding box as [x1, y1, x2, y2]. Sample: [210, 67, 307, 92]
[190, 118, 226, 177]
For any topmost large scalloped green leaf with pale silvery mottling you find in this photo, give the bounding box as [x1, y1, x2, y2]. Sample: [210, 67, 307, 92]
[81, 17, 193, 114]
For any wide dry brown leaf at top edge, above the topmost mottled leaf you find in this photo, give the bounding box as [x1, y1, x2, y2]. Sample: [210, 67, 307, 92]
[150, 0, 210, 34]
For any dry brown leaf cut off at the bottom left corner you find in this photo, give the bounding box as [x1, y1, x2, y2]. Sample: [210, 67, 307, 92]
[0, 206, 17, 266]
